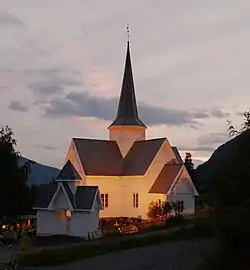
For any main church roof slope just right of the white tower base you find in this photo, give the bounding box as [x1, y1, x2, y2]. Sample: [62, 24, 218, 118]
[123, 138, 165, 175]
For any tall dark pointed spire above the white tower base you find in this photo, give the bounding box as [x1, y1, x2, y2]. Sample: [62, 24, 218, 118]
[111, 37, 146, 127]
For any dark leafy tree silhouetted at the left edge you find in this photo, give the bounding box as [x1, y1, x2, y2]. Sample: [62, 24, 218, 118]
[0, 126, 31, 217]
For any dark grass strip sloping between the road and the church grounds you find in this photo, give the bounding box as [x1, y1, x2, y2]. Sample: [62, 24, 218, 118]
[19, 220, 214, 266]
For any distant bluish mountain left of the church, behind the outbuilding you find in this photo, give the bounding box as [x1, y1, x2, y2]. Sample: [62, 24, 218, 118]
[19, 157, 60, 185]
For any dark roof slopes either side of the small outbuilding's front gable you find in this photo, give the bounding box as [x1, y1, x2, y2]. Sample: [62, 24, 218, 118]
[34, 182, 98, 211]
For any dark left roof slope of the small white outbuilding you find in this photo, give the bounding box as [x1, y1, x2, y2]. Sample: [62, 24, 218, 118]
[34, 183, 57, 208]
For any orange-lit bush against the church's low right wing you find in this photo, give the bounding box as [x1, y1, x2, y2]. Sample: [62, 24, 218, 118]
[148, 200, 179, 219]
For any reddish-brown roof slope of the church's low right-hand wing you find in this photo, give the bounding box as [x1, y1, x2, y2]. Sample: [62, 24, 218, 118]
[149, 164, 183, 194]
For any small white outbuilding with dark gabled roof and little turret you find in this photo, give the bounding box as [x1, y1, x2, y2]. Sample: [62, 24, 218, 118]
[34, 161, 103, 238]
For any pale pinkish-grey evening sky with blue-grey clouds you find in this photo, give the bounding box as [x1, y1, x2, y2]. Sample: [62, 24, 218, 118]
[0, 0, 250, 167]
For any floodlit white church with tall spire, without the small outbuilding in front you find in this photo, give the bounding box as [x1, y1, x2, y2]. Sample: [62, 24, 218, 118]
[58, 41, 198, 219]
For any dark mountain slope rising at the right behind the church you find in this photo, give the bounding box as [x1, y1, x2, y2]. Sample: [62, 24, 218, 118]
[195, 130, 250, 189]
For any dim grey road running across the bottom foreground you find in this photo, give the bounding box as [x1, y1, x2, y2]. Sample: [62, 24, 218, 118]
[25, 239, 217, 270]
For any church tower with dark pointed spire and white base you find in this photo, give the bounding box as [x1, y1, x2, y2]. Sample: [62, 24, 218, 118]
[108, 41, 147, 157]
